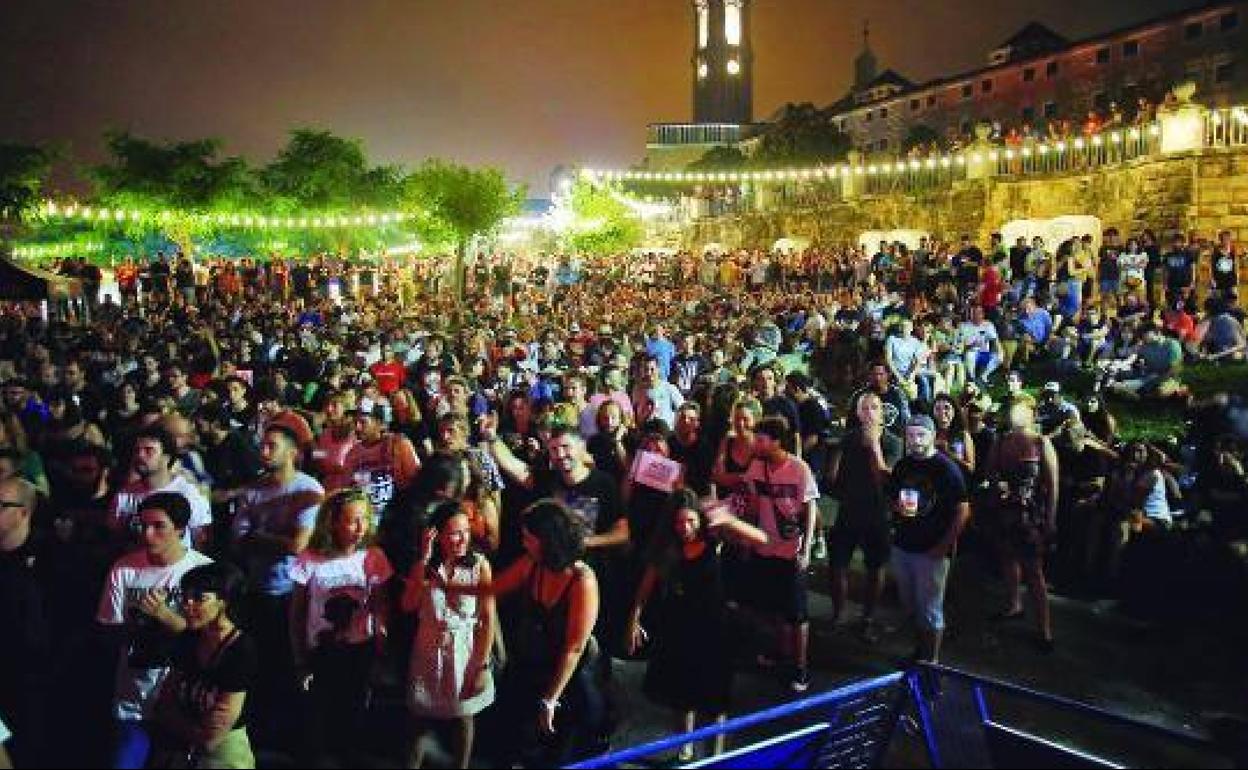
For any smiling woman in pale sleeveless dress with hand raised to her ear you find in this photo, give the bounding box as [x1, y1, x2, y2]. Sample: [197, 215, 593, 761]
[402, 500, 498, 768]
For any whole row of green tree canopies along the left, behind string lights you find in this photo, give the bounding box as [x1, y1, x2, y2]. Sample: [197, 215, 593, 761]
[15, 129, 524, 259]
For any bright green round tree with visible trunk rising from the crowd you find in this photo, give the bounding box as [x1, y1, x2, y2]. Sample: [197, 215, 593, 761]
[403, 160, 524, 300]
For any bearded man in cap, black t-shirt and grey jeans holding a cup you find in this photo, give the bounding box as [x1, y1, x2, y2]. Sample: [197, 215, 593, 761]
[890, 414, 971, 663]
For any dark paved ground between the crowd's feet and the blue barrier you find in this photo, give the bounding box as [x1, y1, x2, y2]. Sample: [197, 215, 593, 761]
[278, 544, 1248, 766]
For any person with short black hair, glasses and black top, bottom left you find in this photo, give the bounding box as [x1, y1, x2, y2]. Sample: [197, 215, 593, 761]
[149, 562, 260, 768]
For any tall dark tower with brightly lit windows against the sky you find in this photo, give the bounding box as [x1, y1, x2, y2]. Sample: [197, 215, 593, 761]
[693, 0, 754, 125]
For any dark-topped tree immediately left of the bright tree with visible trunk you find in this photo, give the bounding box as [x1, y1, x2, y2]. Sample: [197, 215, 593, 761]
[258, 129, 403, 213]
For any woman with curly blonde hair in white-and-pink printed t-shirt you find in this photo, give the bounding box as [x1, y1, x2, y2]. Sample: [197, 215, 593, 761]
[290, 488, 394, 755]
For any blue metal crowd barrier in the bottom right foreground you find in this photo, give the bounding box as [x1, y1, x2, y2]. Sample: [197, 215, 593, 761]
[573, 664, 1223, 769]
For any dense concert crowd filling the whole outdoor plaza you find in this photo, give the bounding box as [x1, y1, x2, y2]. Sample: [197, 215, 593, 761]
[0, 223, 1248, 768]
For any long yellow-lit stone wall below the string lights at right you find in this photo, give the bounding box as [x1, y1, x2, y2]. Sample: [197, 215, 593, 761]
[684, 147, 1248, 248]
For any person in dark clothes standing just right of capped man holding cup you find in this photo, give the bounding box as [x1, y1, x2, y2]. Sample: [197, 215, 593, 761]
[985, 403, 1060, 651]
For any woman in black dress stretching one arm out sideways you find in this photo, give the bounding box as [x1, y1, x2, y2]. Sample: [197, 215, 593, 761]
[628, 489, 768, 761]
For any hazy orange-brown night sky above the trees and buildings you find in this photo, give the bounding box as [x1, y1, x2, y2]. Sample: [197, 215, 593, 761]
[0, 0, 1193, 195]
